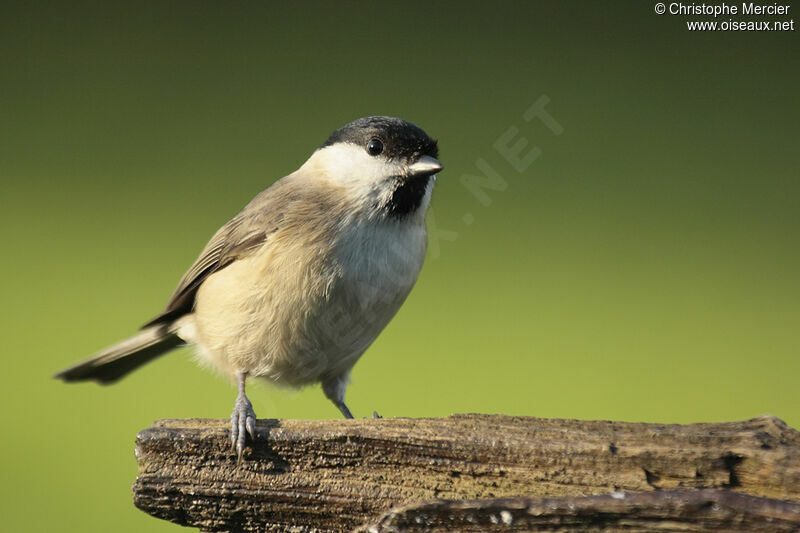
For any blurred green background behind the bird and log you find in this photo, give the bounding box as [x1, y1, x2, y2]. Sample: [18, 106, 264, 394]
[0, 1, 800, 532]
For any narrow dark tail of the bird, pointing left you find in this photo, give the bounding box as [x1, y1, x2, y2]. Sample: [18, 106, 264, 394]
[54, 325, 185, 385]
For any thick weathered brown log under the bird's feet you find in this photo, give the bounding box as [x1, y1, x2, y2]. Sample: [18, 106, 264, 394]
[133, 415, 800, 531]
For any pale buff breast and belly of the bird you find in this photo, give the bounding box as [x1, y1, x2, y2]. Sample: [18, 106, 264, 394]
[194, 216, 426, 386]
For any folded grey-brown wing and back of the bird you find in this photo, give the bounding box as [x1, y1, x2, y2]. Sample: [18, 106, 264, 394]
[142, 176, 293, 328]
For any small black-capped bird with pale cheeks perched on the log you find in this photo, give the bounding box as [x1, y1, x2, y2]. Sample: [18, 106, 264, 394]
[55, 116, 442, 460]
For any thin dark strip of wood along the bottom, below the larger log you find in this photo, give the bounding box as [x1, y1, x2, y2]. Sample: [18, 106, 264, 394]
[357, 489, 800, 533]
